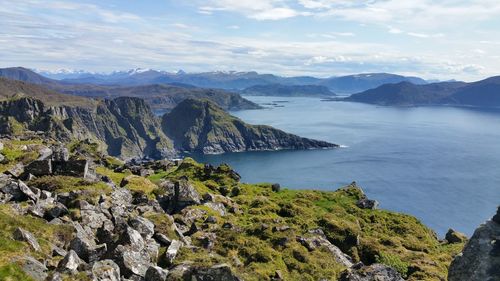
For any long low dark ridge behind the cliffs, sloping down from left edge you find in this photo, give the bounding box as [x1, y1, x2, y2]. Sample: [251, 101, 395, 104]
[0, 67, 260, 112]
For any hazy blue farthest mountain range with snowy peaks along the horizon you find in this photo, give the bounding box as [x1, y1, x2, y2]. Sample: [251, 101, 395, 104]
[33, 69, 427, 94]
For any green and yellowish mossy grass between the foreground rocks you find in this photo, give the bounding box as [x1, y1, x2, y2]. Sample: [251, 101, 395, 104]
[0, 138, 463, 280]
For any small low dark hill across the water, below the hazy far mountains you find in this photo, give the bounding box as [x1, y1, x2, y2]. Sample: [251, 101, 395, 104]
[241, 84, 335, 97]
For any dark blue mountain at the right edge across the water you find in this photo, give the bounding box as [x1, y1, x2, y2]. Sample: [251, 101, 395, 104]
[344, 76, 500, 107]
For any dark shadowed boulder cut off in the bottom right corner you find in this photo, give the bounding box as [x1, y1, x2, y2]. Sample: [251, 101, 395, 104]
[448, 207, 500, 281]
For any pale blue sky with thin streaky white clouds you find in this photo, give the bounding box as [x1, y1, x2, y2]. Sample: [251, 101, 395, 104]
[0, 0, 500, 81]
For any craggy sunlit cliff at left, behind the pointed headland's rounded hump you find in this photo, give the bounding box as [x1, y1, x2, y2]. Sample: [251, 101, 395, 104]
[0, 98, 173, 158]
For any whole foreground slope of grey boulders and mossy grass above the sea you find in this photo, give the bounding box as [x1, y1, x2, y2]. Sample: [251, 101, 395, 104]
[0, 137, 466, 281]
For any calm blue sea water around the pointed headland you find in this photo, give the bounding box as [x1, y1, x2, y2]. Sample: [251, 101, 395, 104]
[191, 97, 500, 236]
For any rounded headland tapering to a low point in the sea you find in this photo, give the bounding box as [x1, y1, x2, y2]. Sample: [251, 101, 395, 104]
[162, 99, 337, 154]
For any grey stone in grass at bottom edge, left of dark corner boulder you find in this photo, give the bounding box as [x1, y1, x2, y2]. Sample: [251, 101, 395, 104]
[338, 264, 404, 281]
